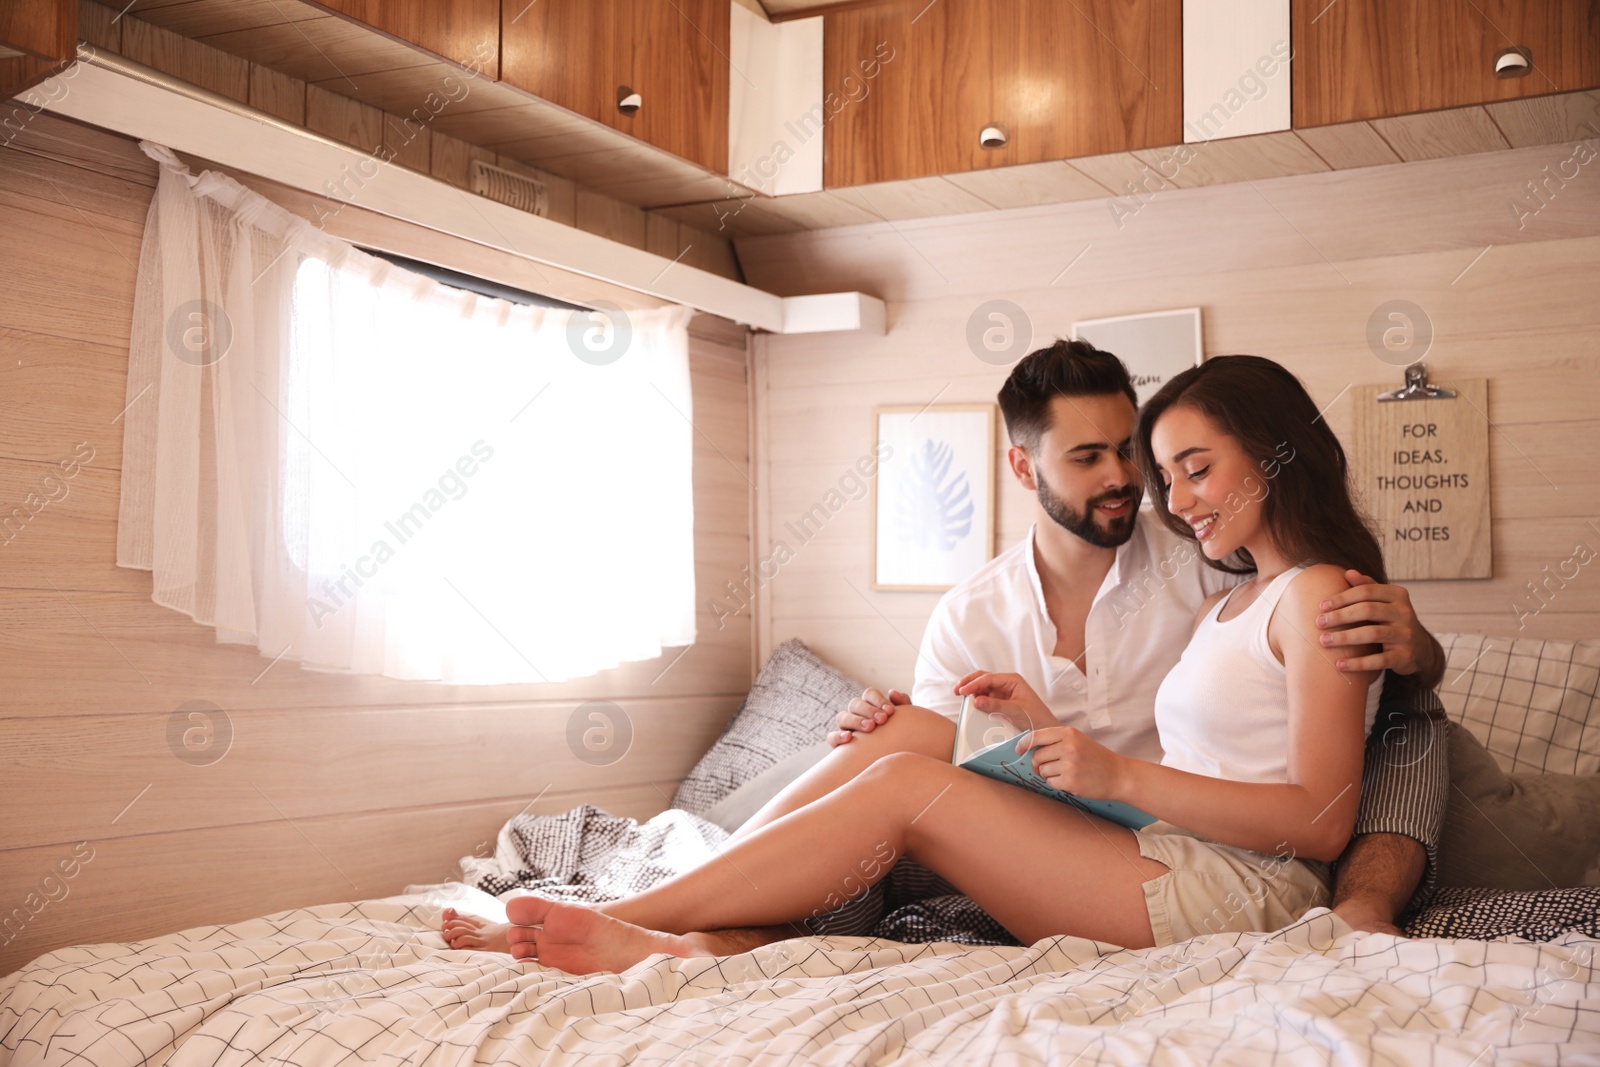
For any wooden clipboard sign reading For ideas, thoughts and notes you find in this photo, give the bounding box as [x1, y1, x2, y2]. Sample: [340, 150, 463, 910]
[1350, 363, 1493, 581]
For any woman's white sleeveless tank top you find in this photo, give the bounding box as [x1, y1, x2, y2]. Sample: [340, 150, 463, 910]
[1155, 566, 1384, 782]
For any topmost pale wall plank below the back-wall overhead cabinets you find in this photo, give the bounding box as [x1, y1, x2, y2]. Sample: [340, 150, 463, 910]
[738, 144, 1600, 302]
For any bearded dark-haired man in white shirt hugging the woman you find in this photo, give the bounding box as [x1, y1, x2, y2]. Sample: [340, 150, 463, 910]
[825, 341, 1448, 933]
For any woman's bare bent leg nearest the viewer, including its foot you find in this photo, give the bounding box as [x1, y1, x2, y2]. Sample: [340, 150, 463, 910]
[506, 742, 1166, 973]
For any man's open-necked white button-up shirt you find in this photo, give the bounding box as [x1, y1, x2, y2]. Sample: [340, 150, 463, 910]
[912, 512, 1242, 761]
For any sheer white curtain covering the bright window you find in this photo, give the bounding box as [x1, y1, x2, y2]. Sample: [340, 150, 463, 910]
[117, 144, 694, 683]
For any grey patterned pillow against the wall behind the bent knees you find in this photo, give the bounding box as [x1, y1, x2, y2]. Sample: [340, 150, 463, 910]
[672, 637, 866, 814]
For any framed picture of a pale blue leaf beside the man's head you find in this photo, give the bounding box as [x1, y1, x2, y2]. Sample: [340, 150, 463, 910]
[872, 403, 995, 592]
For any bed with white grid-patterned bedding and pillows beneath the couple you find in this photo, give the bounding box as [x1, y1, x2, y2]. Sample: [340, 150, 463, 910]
[0, 635, 1600, 1067]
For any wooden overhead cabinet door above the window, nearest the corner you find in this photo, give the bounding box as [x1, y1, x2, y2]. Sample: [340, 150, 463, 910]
[501, 0, 738, 174]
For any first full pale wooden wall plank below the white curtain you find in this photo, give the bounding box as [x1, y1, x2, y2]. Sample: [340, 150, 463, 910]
[0, 697, 741, 848]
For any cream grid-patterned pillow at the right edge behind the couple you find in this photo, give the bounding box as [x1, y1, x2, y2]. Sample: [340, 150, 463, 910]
[1438, 633, 1600, 774]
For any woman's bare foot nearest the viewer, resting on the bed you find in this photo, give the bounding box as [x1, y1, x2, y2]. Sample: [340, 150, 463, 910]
[506, 896, 694, 974]
